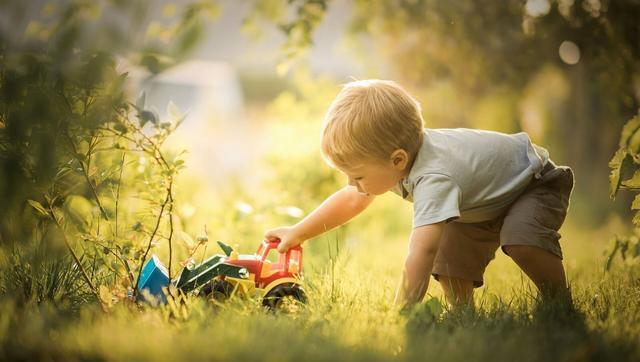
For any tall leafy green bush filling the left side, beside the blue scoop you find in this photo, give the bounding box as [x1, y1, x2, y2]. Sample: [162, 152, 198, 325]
[0, 1, 215, 304]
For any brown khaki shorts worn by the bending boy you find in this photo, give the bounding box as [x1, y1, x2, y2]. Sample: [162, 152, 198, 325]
[432, 161, 573, 288]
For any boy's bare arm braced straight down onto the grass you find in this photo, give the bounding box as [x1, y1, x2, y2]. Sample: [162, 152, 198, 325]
[395, 222, 444, 308]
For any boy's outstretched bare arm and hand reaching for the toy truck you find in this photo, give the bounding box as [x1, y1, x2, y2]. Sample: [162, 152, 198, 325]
[264, 186, 375, 253]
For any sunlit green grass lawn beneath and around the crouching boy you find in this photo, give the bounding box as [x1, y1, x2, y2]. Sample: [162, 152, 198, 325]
[0, 211, 640, 361]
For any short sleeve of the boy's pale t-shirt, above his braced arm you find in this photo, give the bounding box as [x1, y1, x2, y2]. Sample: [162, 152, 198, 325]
[413, 174, 462, 228]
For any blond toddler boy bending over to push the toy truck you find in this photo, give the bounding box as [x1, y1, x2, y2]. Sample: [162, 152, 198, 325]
[265, 80, 573, 306]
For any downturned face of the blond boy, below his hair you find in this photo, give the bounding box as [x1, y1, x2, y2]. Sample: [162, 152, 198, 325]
[338, 162, 404, 195]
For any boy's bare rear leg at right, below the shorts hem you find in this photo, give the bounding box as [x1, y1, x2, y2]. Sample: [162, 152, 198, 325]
[503, 245, 569, 298]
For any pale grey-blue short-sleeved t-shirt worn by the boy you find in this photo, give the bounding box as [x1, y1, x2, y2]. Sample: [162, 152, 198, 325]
[392, 128, 549, 228]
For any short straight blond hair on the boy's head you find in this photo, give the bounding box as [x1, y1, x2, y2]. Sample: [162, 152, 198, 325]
[321, 79, 424, 167]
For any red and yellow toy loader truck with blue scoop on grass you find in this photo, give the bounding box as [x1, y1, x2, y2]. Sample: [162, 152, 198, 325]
[138, 240, 307, 309]
